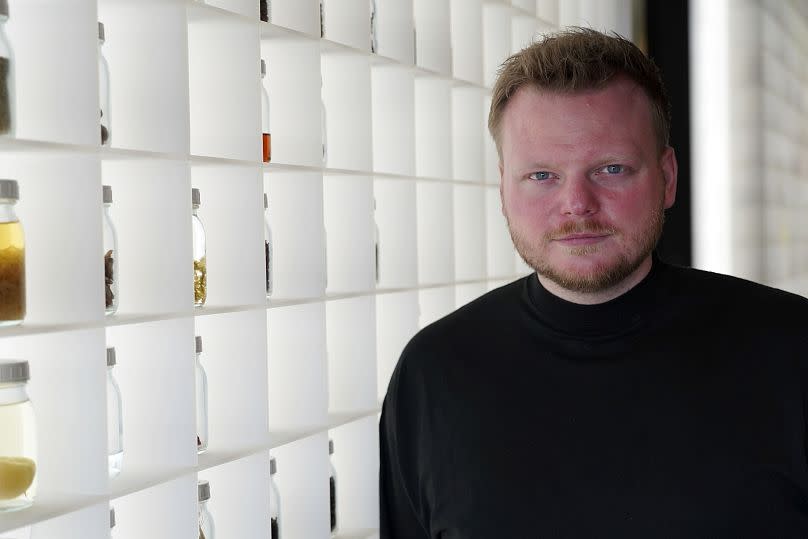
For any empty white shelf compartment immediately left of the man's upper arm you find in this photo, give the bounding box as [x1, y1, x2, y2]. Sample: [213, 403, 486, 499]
[326, 296, 377, 413]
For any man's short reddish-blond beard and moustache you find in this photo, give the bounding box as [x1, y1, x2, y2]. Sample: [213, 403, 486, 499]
[505, 198, 665, 293]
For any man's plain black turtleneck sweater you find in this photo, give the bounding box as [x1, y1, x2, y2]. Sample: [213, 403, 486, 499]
[380, 256, 808, 539]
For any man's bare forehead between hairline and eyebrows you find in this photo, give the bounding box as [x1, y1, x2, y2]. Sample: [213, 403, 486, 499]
[501, 79, 656, 159]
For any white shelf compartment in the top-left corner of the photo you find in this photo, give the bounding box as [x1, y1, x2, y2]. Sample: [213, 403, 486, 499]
[8, 2, 101, 146]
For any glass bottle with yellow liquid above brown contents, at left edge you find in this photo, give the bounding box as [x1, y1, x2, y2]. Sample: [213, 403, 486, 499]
[0, 180, 25, 327]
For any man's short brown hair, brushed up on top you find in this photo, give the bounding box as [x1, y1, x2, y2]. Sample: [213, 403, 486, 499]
[488, 27, 671, 161]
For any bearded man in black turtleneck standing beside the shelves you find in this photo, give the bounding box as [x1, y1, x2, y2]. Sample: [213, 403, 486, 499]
[380, 29, 808, 539]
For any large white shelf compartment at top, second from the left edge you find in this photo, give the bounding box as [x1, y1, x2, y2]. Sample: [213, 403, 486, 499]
[96, 0, 190, 155]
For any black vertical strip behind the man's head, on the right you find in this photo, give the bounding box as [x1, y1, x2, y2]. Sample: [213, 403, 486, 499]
[644, 0, 692, 266]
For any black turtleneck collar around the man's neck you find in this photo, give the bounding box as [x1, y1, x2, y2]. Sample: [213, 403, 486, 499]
[526, 251, 667, 339]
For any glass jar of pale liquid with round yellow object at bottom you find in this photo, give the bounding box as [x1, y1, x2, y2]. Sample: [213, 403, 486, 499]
[0, 360, 37, 512]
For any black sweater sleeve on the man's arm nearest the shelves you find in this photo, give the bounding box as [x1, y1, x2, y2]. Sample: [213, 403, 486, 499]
[379, 346, 429, 539]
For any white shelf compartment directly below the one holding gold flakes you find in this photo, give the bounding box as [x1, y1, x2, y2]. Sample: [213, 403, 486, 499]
[195, 309, 269, 464]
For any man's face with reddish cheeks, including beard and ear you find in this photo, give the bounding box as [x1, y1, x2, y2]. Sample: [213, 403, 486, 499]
[500, 78, 676, 294]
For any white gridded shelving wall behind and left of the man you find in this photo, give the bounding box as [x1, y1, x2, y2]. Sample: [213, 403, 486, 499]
[0, 0, 630, 539]
